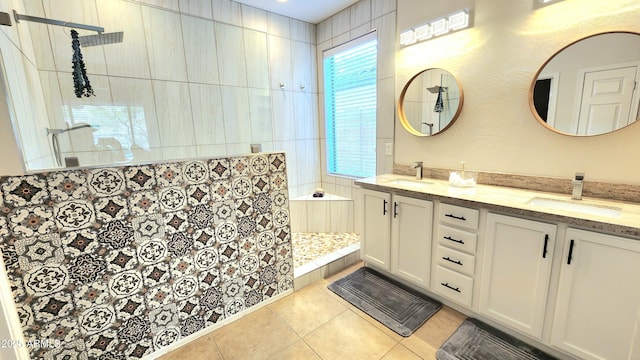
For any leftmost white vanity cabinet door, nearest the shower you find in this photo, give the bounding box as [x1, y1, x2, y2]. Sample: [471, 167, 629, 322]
[360, 190, 391, 270]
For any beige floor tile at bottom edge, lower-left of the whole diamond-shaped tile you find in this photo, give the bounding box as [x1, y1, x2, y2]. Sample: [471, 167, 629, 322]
[211, 307, 299, 360]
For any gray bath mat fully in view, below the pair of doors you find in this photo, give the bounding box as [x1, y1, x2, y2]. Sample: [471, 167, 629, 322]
[328, 267, 442, 337]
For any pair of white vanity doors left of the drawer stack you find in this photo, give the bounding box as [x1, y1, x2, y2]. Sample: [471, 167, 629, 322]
[361, 190, 433, 288]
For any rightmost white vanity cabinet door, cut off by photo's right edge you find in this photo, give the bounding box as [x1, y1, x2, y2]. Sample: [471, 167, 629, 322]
[551, 229, 640, 360]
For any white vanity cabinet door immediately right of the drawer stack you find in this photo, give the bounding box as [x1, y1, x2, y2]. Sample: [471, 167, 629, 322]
[480, 214, 556, 339]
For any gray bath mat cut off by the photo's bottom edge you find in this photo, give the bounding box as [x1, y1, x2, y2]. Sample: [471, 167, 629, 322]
[436, 319, 555, 360]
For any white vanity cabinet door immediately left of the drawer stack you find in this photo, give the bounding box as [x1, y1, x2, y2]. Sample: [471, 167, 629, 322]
[391, 195, 433, 287]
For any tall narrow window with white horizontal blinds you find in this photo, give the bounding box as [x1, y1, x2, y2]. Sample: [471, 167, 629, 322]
[323, 31, 378, 178]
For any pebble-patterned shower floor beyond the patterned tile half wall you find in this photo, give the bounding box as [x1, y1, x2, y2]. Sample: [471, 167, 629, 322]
[291, 233, 360, 268]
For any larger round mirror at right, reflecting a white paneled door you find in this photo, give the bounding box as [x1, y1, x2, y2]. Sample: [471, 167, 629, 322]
[529, 32, 640, 136]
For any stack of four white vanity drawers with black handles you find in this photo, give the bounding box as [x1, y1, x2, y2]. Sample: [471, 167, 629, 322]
[433, 204, 480, 307]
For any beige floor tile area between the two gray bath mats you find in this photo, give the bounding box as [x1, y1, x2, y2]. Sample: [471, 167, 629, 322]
[401, 306, 465, 359]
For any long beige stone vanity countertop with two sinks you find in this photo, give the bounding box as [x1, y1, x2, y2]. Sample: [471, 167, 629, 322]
[355, 174, 640, 239]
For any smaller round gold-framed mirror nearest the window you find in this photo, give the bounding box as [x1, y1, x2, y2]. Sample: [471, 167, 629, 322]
[398, 68, 463, 136]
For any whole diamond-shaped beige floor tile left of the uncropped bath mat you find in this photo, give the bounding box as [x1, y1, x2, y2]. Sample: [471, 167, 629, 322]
[270, 285, 347, 337]
